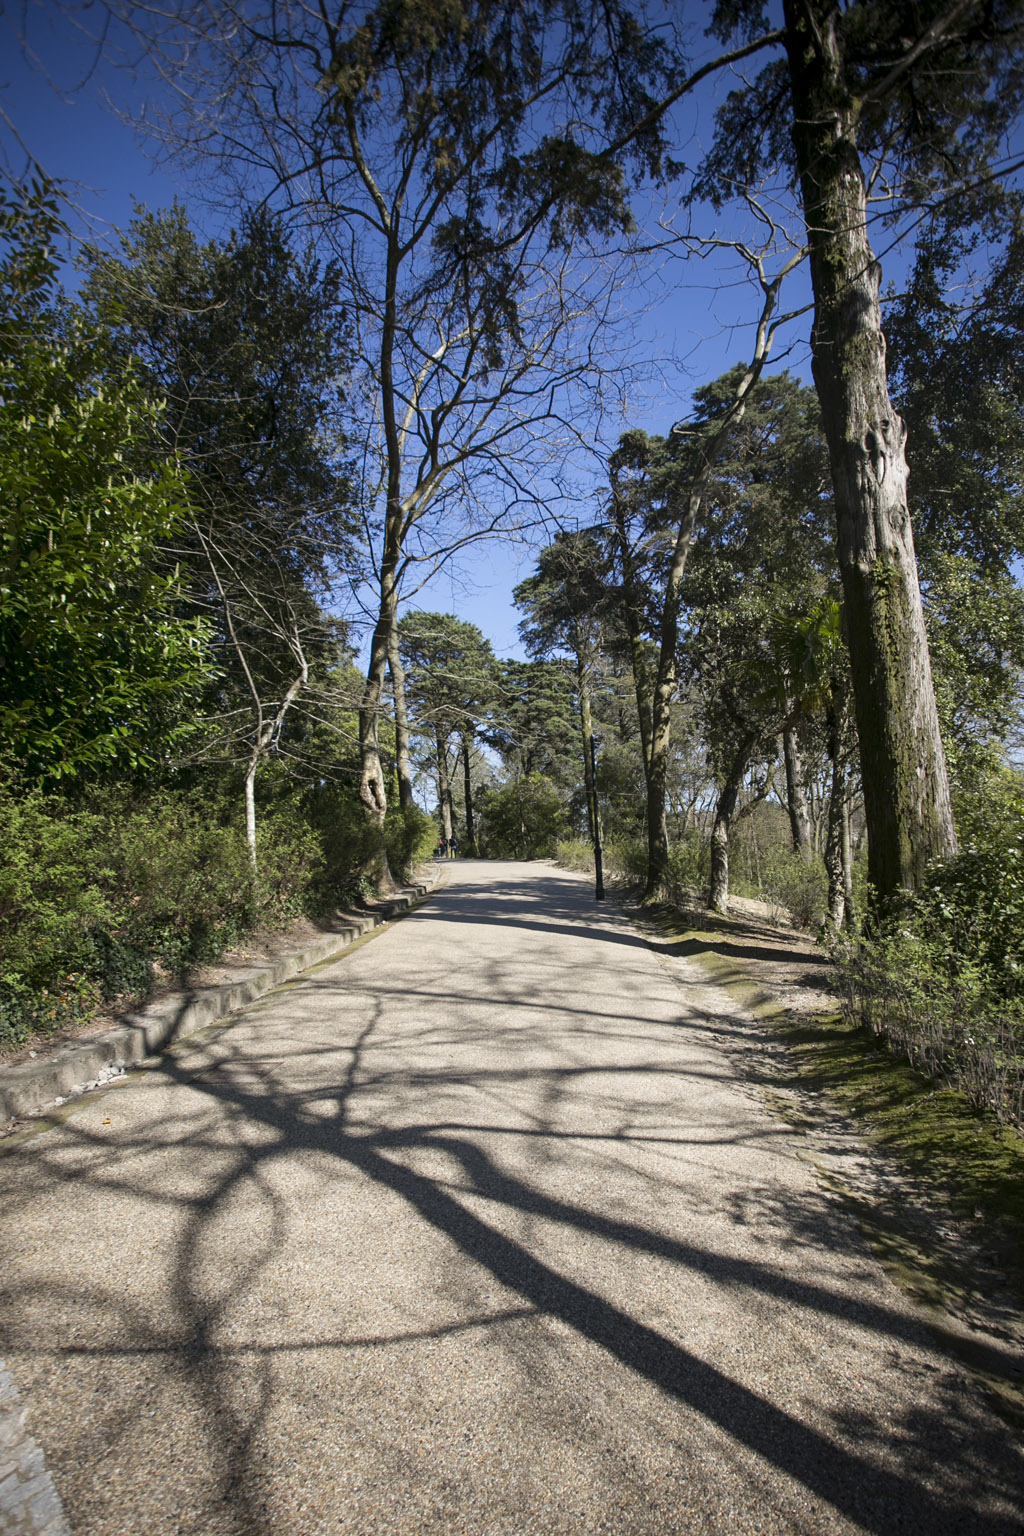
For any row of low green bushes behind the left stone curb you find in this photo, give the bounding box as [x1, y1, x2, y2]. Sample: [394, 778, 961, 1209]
[0, 774, 433, 1049]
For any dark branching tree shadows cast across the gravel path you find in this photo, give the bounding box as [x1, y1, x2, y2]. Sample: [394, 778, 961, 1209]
[4, 883, 1024, 1536]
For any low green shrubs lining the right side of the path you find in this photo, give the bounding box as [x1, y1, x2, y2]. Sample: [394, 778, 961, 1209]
[557, 803, 1024, 1135]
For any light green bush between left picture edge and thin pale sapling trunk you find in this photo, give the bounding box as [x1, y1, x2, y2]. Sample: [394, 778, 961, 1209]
[0, 790, 247, 1048]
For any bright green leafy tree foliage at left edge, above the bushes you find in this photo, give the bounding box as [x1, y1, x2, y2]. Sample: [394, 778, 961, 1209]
[0, 181, 209, 779]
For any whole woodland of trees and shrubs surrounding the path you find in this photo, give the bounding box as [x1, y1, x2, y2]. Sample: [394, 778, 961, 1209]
[0, 0, 1024, 1126]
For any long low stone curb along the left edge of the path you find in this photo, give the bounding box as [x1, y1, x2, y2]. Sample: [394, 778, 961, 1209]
[0, 871, 439, 1126]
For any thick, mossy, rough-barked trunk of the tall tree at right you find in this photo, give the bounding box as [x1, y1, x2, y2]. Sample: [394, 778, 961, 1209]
[785, 0, 956, 899]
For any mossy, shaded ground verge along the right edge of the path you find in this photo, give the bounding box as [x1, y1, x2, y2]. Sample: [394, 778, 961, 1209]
[649, 906, 1024, 1430]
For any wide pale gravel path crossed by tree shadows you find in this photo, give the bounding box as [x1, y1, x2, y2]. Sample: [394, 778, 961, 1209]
[0, 863, 1024, 1536]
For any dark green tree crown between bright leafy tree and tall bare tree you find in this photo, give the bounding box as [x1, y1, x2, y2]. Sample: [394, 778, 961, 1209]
[83, 204, 356, 804]
